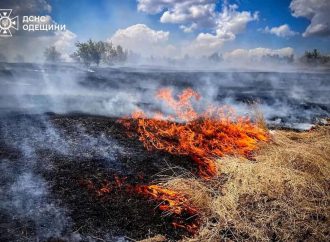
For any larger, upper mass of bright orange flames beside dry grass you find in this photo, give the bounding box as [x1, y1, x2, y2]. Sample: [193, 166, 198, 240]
[120, 88, 269, 179]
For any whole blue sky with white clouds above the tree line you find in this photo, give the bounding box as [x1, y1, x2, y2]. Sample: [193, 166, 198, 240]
[0, 0, 330, 60]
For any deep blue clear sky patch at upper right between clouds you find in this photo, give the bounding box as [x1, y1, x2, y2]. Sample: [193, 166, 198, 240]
[231, 0, 330, 53]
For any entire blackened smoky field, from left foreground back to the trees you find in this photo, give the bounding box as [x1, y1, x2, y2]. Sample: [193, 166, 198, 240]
[0, 63, 330, 241]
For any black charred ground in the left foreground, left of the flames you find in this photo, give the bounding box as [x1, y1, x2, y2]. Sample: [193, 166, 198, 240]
[0, 114, 200, 241]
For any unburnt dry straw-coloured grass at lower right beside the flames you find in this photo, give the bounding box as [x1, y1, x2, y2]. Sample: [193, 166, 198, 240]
[158, 126, 330, 242]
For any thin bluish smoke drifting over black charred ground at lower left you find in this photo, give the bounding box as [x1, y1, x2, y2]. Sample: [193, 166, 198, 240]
[0, 105, 123, 241]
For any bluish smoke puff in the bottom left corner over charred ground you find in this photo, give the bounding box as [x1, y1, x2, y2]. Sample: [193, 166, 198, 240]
[0, 147, 70, 241]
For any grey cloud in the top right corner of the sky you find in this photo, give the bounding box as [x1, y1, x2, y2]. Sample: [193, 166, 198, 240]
[290, 0, 330, 37]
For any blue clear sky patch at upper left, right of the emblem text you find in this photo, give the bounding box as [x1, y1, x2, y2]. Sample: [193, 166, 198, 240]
[52, 0, 186, 41]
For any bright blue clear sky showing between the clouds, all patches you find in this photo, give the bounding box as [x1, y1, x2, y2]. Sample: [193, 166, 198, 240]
[51, 0, 330, 53]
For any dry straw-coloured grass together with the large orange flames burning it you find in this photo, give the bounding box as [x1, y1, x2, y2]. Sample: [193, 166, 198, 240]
[121, 89, 330, 242]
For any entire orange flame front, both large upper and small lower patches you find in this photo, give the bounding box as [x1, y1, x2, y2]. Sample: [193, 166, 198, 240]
[85, 88, 269, 234]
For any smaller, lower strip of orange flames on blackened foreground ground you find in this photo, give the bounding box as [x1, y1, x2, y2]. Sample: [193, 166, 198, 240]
[83, 176, 199, 234]
